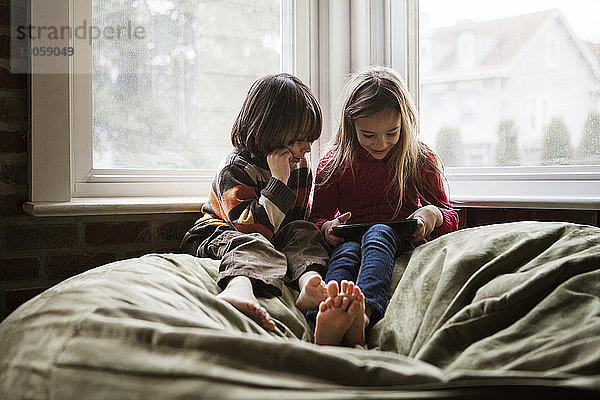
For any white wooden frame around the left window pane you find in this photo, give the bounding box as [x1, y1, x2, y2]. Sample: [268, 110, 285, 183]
[24, 0, 315, 216]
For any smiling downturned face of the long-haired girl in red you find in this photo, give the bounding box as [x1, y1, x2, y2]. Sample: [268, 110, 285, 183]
[354, 110, 402, 160]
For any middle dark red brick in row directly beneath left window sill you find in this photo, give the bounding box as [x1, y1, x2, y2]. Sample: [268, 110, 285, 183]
[85, 221, 152, 246]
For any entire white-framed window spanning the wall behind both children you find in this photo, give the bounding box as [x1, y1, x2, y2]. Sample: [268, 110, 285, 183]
[23, 0, 600, 214]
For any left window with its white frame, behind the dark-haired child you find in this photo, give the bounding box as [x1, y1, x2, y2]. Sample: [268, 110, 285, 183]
[24, 0, 310, 209]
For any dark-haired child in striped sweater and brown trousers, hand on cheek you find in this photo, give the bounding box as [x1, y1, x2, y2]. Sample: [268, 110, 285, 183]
[182, 74, 360, 338]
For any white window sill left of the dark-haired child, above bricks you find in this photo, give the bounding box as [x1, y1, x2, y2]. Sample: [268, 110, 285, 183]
[23, 197, 206, 217]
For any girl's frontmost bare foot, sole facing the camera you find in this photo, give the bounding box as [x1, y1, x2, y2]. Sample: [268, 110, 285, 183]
[315, 281, 361, 345]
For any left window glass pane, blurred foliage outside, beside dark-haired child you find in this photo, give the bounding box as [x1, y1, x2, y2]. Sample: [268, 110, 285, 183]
[93, 0, 281, 169]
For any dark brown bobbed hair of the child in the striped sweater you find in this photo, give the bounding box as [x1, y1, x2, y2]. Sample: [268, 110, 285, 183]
[231, 73, 322, 157]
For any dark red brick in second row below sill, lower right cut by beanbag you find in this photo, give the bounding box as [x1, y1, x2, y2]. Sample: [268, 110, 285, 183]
[47, 253, 116, 279]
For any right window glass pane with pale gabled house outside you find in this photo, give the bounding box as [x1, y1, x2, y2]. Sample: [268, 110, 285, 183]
[419, 0, 600, 167]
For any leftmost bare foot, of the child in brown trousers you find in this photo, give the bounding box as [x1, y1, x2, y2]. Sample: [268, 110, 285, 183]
[217, 276, 275, 331]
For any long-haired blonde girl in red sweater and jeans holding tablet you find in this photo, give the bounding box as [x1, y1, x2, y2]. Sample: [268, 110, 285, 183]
[308, 67, 458, 345]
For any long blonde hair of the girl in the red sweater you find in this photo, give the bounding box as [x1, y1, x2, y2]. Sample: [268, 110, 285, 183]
[322, 66, 444, 216]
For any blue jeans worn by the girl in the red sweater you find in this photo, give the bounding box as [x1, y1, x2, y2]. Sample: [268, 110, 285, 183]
[307, 224, 413, 324]
